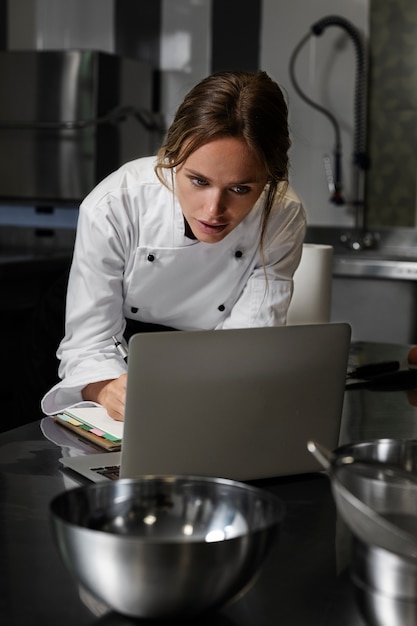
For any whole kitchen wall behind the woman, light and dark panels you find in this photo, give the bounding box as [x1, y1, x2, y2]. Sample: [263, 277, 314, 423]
[4, 0, 417, 227]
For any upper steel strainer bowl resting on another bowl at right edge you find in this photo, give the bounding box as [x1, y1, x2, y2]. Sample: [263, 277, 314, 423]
[330, 439, 417, 552]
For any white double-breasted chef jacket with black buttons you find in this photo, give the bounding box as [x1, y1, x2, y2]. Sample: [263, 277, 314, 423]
[42, 157, 306, 414]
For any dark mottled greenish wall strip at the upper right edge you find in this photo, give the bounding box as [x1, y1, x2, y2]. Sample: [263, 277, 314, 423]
[366, 0, 417, 226]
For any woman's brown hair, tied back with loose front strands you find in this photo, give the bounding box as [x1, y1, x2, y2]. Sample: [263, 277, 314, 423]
[155, 71, 291, 249]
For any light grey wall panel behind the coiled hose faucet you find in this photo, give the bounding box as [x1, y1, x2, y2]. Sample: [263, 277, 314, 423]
[261, 0, 369, 226]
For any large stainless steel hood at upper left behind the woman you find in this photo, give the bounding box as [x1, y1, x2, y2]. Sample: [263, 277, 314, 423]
[0, 50, 160, 207]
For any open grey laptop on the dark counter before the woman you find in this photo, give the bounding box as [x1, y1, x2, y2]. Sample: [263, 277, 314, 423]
[61, 323, 351, 481]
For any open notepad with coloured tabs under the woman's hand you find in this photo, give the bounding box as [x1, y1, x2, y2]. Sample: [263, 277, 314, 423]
[54, 407, 123, 451]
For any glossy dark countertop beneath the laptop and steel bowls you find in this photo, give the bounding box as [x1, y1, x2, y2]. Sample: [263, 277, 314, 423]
[0, 343, 417, 626]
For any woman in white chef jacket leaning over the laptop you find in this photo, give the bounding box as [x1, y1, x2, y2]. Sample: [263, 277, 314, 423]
[42, 72, 305, 420]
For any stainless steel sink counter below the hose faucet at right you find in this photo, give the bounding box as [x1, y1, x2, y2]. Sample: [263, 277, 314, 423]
[306, 226, 417, 344]
